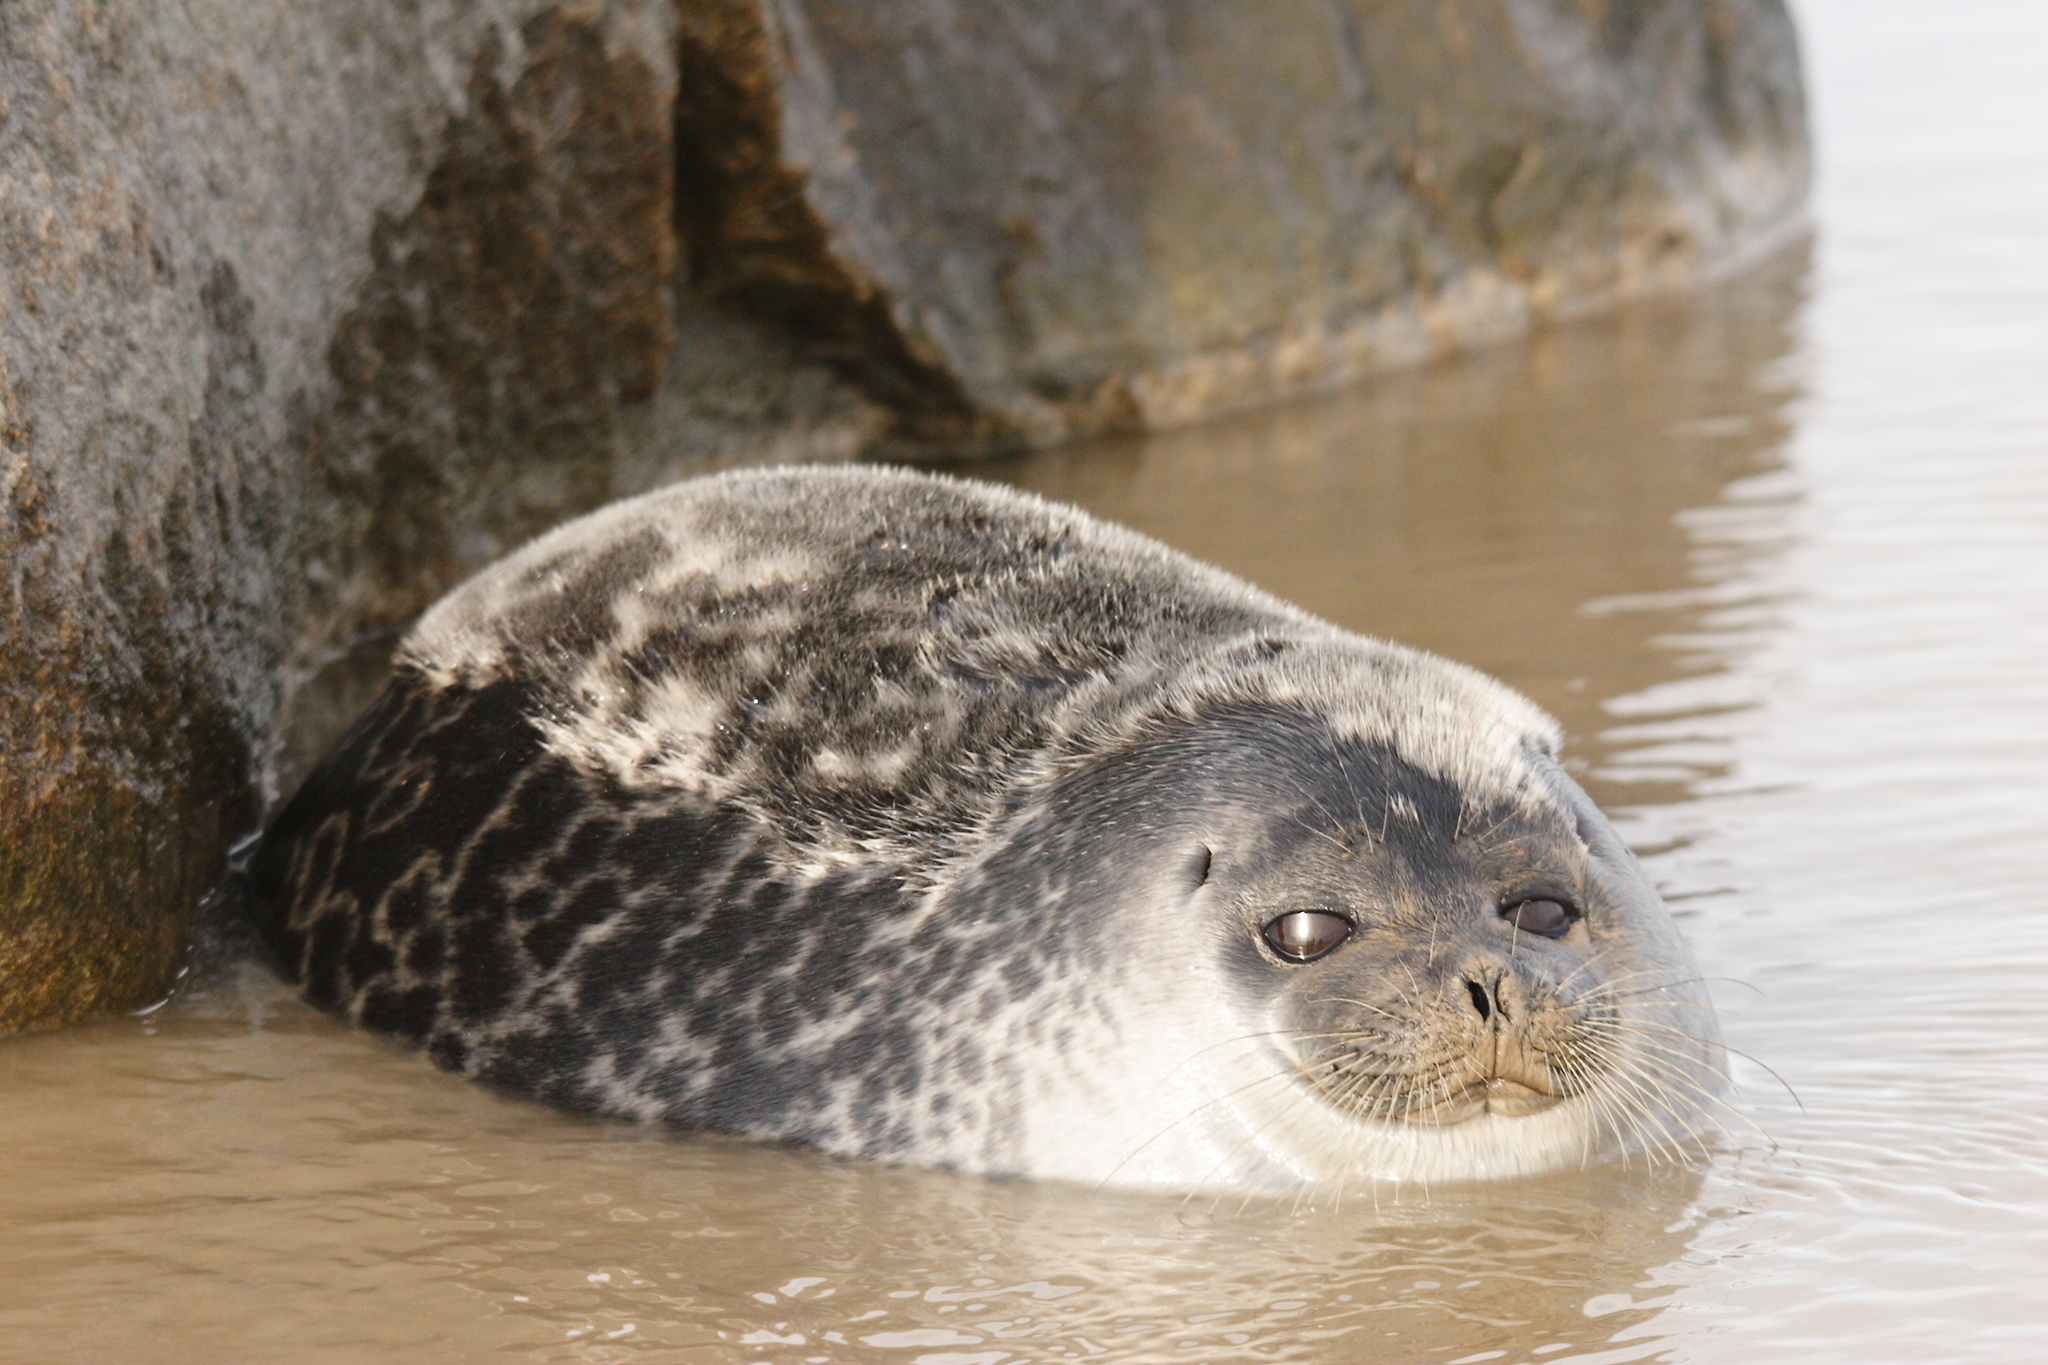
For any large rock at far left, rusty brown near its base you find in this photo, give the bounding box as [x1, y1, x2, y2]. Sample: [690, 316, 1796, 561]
[0, 0, 674, 1029]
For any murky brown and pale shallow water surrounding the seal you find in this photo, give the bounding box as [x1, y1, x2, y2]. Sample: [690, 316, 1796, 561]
[0, 0, 2048, 1365]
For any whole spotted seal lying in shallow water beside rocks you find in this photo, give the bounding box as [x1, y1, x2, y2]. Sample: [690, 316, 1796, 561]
[248, 467, 1720, 1189]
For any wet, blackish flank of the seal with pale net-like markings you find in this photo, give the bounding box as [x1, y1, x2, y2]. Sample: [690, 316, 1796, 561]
[250, 679, 1081, 1166]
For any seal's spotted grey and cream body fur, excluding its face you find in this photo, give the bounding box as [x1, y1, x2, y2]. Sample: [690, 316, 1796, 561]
[250, 469, 1712, 1185]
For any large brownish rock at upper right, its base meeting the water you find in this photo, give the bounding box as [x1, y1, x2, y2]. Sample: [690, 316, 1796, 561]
[682, 0, 1806, 444]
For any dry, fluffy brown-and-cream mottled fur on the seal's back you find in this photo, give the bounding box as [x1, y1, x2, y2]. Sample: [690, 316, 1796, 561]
[405, 471, 1302, 876]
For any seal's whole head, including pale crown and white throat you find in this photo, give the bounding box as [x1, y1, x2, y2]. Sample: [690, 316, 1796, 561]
[933, 636, 1722, 1187]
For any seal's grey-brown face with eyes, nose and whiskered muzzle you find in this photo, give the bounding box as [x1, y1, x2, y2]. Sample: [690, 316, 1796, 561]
[1237, 812, 1618, 1126]
